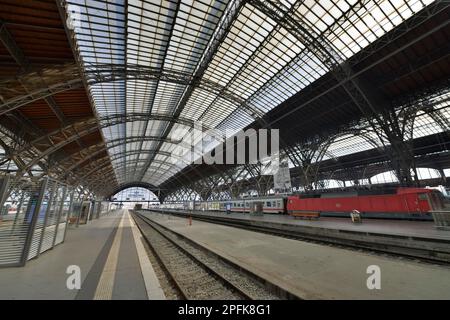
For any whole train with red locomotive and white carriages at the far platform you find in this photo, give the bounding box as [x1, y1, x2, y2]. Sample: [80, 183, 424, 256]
[160, 188, 444, 220]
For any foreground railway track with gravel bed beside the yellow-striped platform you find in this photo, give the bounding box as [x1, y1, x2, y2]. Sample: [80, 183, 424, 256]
[132, 212, 288, 300]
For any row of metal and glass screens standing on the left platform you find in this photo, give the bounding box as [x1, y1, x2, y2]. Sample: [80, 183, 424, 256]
[0, 176, 109, 267]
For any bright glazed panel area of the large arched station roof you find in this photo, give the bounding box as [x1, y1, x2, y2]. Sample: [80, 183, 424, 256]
[60, 0, 442, 186]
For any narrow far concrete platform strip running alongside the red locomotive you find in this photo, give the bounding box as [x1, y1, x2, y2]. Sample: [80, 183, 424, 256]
[157, 211, 450, 240]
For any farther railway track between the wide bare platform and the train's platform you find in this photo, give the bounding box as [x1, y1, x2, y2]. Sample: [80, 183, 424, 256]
[148, 211, 450, 265]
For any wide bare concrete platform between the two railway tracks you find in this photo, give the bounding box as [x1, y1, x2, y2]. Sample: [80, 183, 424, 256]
[141, 211, 450, 299]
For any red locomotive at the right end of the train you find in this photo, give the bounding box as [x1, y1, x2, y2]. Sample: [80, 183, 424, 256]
[287, 188, 443, 220]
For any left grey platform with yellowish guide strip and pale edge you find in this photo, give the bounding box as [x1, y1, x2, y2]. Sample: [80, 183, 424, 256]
[0, 210, 165, 300]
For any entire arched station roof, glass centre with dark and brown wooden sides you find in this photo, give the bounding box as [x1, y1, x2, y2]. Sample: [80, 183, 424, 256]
[0, 0, 450, 196]
